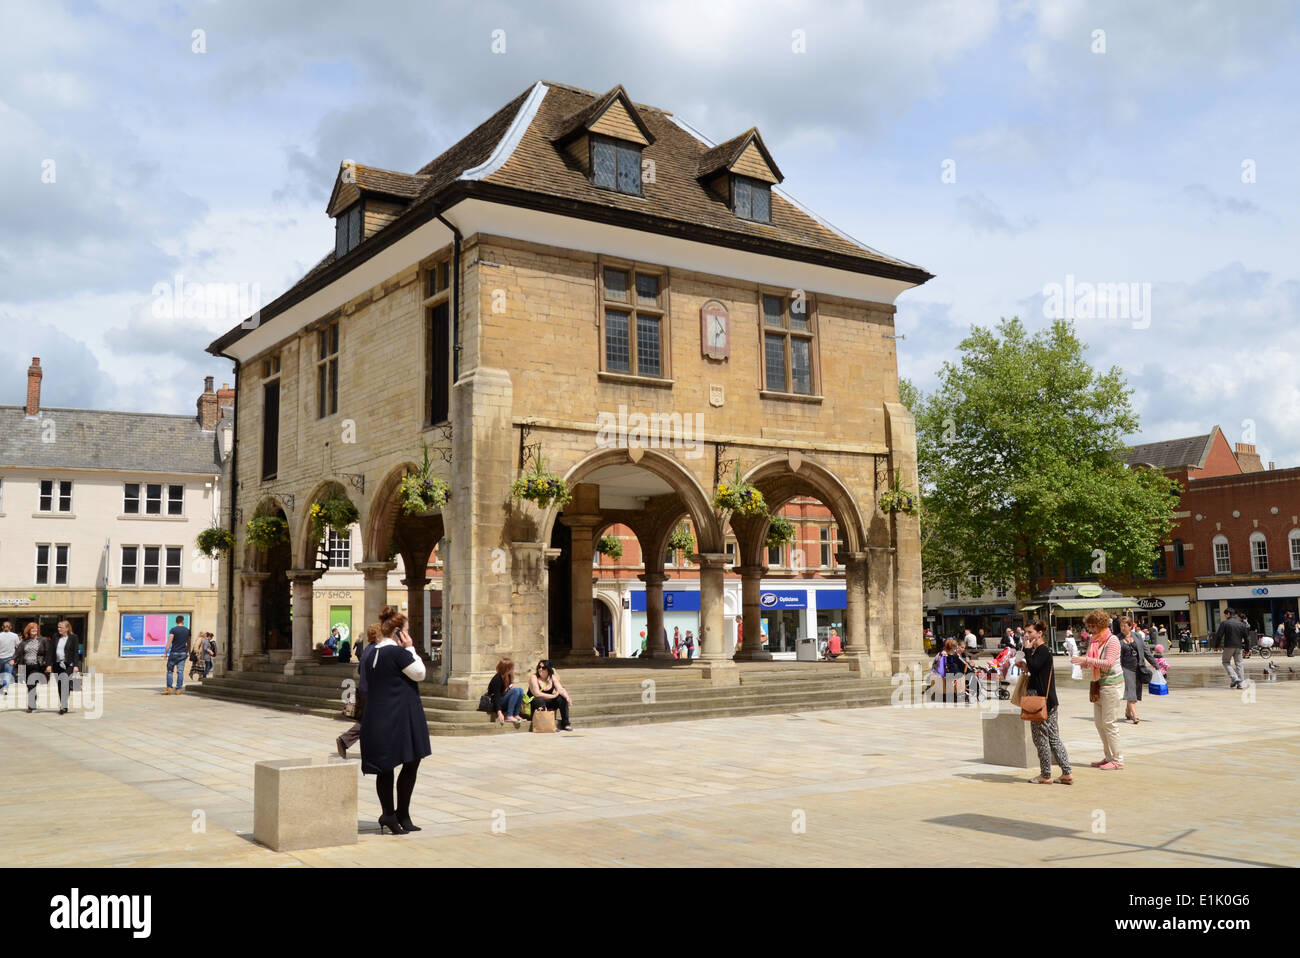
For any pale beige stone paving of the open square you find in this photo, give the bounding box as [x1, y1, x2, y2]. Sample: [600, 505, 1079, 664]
[0, 680, 1300, 868]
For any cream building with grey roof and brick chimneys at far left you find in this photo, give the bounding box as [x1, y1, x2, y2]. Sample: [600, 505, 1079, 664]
[0, 357, 234, 682]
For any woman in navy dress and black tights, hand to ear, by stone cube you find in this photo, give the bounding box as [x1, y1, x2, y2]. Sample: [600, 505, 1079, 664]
[361, 606, 433, 835]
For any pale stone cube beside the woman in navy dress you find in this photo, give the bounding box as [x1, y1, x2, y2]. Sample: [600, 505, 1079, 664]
[252, 758, 359, 851]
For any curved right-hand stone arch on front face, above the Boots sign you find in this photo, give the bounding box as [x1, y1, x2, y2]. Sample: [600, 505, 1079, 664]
[732, 455, 867, 565]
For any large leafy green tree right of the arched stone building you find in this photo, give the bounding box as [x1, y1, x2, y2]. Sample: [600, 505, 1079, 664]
[905, 318, 1179, 595]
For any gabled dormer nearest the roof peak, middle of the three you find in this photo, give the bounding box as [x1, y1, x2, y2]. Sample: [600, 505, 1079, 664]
[551, 86, 654, 196]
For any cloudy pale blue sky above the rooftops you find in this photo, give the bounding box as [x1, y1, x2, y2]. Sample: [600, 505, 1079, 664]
[0, 0, 1300, 468]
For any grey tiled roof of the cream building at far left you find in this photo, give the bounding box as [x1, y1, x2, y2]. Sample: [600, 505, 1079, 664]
[0, 406, 221, 476]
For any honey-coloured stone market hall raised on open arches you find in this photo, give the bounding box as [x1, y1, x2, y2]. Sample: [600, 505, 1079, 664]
[209, 82, 930, 698]
